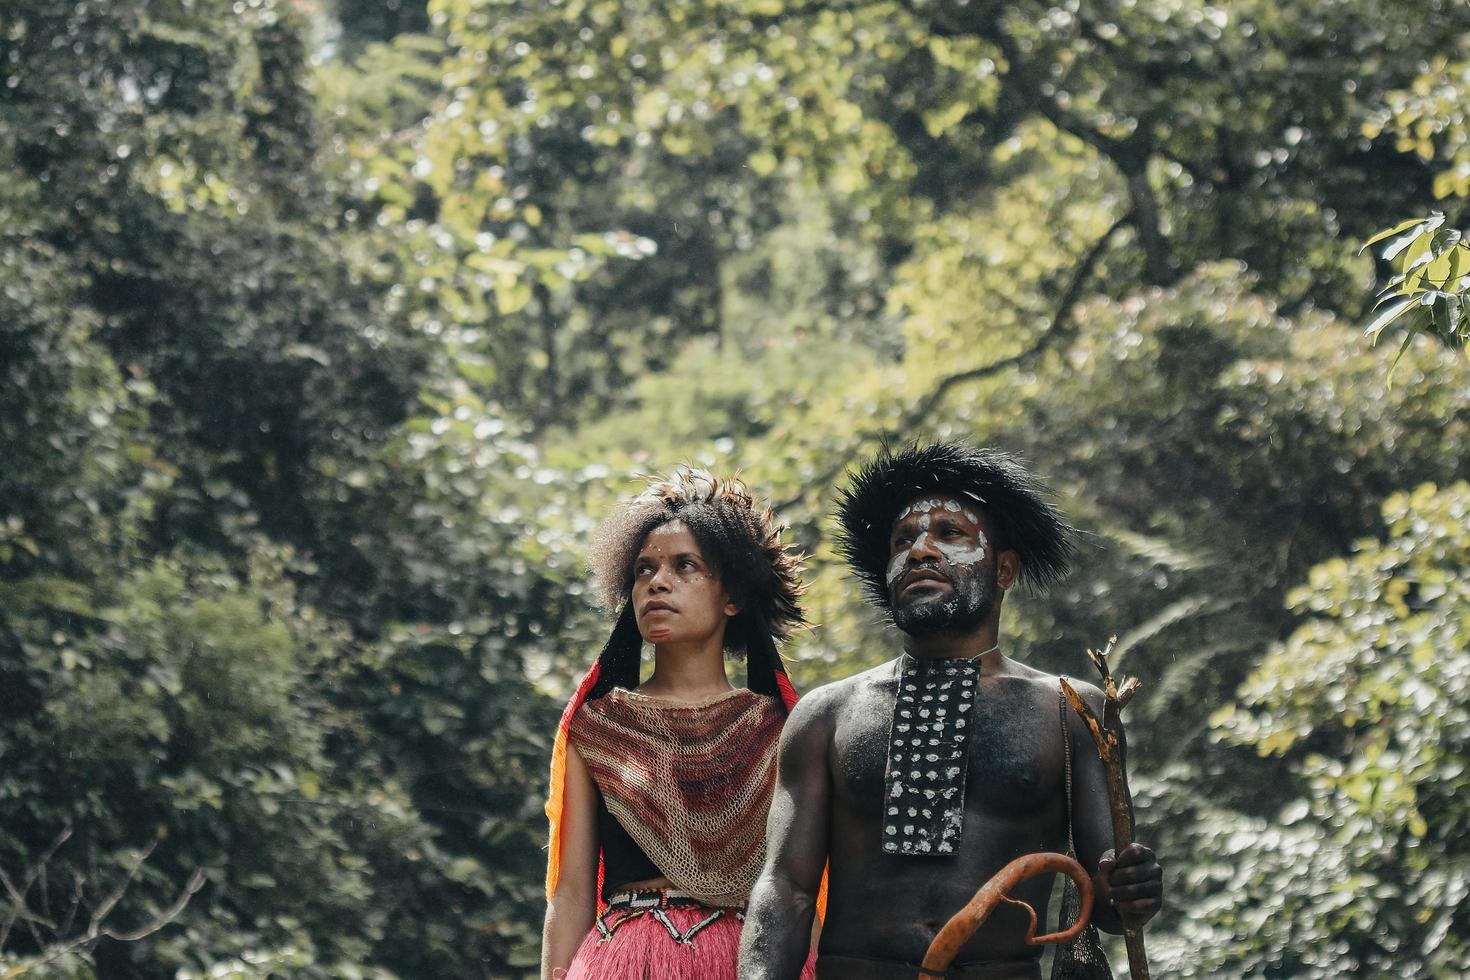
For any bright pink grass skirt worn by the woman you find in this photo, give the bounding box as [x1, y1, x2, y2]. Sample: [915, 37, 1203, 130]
[566, 905, 816, 980]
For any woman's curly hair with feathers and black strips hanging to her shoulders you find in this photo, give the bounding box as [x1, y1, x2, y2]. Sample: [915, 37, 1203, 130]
[587, 467, 804, 696]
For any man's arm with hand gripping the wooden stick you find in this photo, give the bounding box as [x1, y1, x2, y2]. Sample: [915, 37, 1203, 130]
[1067, 680, 1164, 933]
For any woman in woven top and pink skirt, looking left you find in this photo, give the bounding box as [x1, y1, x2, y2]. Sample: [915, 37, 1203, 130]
[541, 470, 803, 980]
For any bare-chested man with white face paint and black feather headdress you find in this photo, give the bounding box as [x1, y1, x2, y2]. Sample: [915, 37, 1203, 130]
[739, 444, 1163, 980]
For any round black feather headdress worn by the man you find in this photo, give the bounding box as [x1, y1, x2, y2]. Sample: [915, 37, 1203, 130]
[838, 442, 1075, 610]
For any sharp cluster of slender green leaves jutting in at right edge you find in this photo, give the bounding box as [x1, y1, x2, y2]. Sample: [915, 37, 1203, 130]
[1358, 212, 1470, 375]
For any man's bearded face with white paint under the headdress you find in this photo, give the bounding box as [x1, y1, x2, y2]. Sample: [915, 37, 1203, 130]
[888, 495, 998, 633]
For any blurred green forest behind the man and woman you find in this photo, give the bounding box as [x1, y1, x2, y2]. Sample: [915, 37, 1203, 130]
[0, 0, 1470, 980]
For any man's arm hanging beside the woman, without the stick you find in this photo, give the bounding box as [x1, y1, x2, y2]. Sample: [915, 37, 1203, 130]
[739, 689, 832, 980]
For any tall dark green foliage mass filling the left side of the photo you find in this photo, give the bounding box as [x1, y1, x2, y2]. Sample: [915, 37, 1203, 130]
[0, 1, 561, 977]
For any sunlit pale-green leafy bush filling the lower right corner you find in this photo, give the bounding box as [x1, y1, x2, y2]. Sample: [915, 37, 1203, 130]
[1170, 483, 1470, 977]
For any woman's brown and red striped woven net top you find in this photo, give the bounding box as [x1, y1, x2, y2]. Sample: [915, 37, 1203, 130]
[569, 688, 786, 905]
